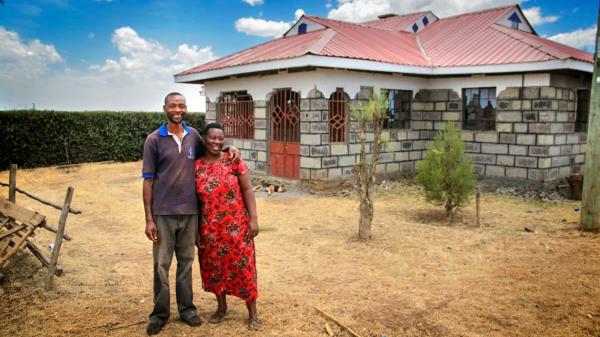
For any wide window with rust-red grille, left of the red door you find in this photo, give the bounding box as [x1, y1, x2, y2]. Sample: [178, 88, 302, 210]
[217, 91, 254, 139]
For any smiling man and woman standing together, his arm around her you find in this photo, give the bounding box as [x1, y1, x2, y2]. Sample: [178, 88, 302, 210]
[142, 92, 259, 335]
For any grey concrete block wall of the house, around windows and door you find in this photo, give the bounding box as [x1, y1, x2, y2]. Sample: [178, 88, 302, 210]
[206, 87, 587, 181]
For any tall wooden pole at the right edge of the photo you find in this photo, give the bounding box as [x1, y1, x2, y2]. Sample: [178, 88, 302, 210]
[579, 8, 600, 231]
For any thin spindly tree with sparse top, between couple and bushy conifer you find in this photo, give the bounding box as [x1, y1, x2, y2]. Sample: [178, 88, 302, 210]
[352, 93, 387, 240]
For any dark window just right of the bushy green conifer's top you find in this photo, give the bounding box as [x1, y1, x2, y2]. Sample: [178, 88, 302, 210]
[463, 88, 496, 130]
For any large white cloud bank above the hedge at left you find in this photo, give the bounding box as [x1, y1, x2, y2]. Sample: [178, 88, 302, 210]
[0, 27, 216, 111]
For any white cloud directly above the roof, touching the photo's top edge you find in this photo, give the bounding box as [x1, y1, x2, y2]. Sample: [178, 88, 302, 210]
[328, 0, 515, 22]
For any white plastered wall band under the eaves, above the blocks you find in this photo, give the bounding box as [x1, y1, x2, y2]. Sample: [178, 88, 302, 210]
[205, 69, 550, 102]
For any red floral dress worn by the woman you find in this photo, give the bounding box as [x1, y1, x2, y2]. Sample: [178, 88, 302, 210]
[195, 153, 258, 301]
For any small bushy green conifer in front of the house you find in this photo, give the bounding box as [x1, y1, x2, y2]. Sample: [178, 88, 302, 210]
[417, 123, 475, 219]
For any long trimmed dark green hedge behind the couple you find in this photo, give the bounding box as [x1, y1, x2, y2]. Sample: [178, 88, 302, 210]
[0, 110, 204, 170]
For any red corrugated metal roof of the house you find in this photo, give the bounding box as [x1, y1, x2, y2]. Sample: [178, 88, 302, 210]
[177, 5, 593, 76]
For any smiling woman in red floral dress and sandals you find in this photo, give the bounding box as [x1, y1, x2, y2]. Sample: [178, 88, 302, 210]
[195, 123, 260, 330]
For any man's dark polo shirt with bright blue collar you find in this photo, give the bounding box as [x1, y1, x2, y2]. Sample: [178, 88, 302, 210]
[142, 123, 204, 215]
